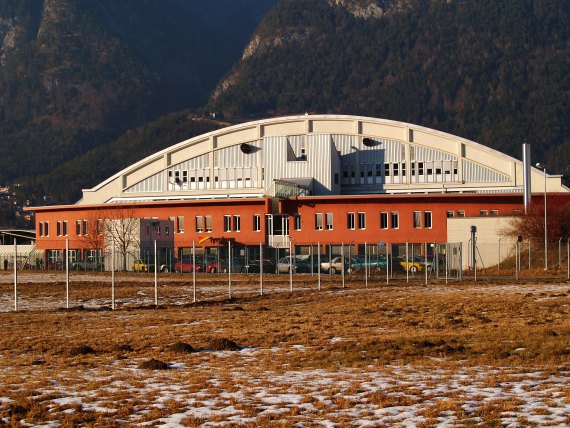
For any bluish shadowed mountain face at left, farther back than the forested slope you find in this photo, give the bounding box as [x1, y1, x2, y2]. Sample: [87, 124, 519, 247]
[0, 0, 274, 191]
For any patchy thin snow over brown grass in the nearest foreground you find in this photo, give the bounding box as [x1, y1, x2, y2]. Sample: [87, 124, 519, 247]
[0, 345, 570, 427]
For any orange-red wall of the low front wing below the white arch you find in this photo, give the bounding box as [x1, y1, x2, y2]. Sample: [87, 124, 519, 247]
[33, 194, 570, 250]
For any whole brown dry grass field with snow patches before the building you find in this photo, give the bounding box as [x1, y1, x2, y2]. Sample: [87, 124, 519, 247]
[0, 273, 570, 427]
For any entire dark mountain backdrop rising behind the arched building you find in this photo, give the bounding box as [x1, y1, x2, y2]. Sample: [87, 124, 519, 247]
[0, 0, 570, 219]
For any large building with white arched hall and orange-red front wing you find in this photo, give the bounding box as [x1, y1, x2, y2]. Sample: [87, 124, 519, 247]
[27, 115, 570, 268]
